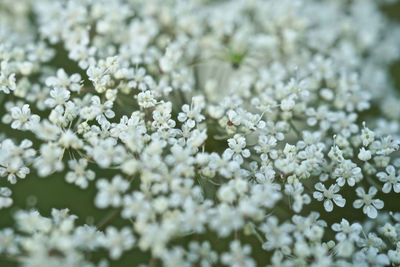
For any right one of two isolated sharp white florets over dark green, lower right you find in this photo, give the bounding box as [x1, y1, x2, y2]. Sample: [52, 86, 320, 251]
[353, 187, 384, 219]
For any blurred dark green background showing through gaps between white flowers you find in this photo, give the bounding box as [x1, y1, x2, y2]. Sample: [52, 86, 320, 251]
[0, 3, 400, 267]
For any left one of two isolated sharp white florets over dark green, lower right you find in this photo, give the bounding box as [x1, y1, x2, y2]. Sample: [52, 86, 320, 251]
[313, 183, 346, 212]
